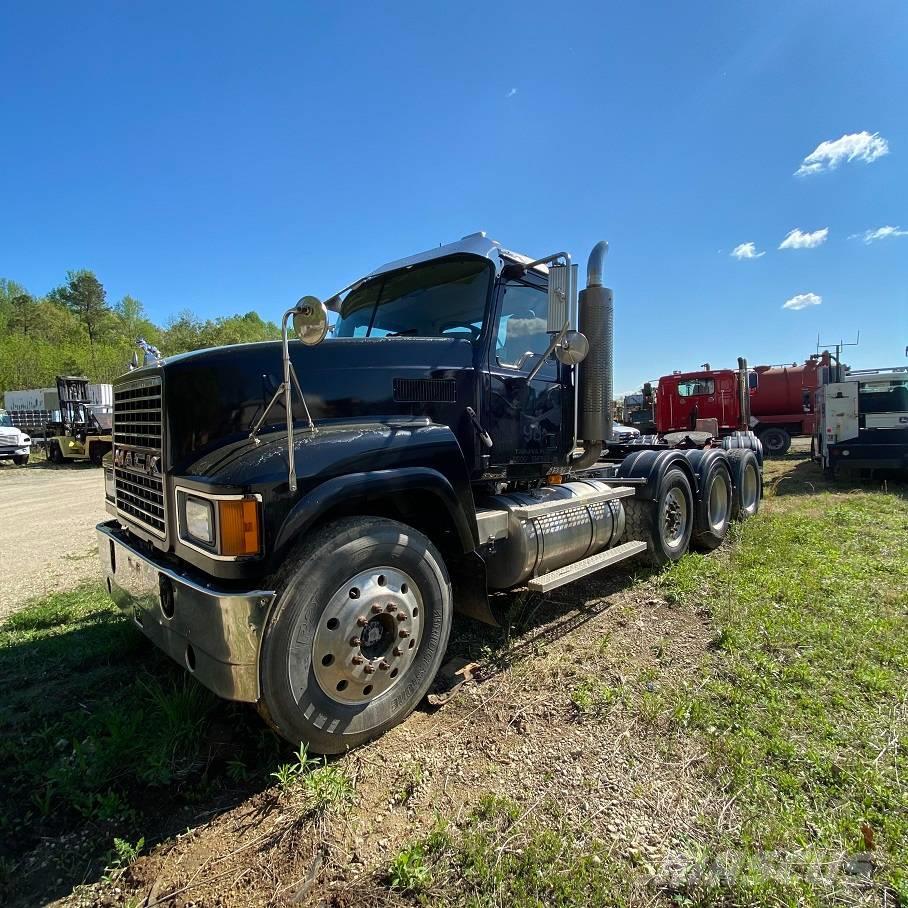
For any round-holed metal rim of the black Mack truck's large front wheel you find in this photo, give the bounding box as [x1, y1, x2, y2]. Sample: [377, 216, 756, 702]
[312, 566, 423, 704]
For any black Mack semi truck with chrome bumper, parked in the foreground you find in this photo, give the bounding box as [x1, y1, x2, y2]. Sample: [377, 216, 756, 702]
[98, 233, 761, 753]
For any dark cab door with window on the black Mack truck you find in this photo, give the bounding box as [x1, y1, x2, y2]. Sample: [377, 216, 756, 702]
[482, 275, 573, 478]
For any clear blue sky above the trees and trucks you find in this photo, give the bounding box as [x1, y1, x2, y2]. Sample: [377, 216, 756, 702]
[0, 0, 908, 391]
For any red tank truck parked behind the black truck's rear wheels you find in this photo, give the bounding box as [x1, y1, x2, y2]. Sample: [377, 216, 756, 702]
[653, 352, 830, 455]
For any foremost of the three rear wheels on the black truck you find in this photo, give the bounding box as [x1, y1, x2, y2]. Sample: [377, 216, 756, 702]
[624, 467, 694, 567]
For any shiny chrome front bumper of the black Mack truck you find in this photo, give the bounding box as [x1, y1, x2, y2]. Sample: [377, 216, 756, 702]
[97, 520, 275, 703]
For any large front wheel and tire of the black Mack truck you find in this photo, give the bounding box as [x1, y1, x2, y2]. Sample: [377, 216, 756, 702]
[259, 517, 453, 754]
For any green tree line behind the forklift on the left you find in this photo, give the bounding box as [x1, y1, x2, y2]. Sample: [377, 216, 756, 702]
[0, 270, 281, 392]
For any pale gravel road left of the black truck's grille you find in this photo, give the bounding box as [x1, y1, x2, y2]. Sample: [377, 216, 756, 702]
[0, 462, 105, 621]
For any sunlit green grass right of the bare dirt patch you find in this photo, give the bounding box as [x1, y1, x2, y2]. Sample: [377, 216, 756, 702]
[660, 492, 908, 904]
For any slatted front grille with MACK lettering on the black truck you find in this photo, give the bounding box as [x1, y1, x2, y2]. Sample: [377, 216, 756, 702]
[113, 376, 167, 538]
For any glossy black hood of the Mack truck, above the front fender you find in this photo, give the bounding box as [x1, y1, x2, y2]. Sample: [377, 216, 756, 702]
[125, 337, 476, 473]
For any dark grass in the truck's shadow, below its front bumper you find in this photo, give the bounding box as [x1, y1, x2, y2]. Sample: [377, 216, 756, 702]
[0, 584, 277, 882]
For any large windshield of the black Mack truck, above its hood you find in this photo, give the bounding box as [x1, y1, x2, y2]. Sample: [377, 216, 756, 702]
[334, 256, 490, 340]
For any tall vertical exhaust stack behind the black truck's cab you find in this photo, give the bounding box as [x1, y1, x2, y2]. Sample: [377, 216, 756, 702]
[573, 240, 614, 470]
